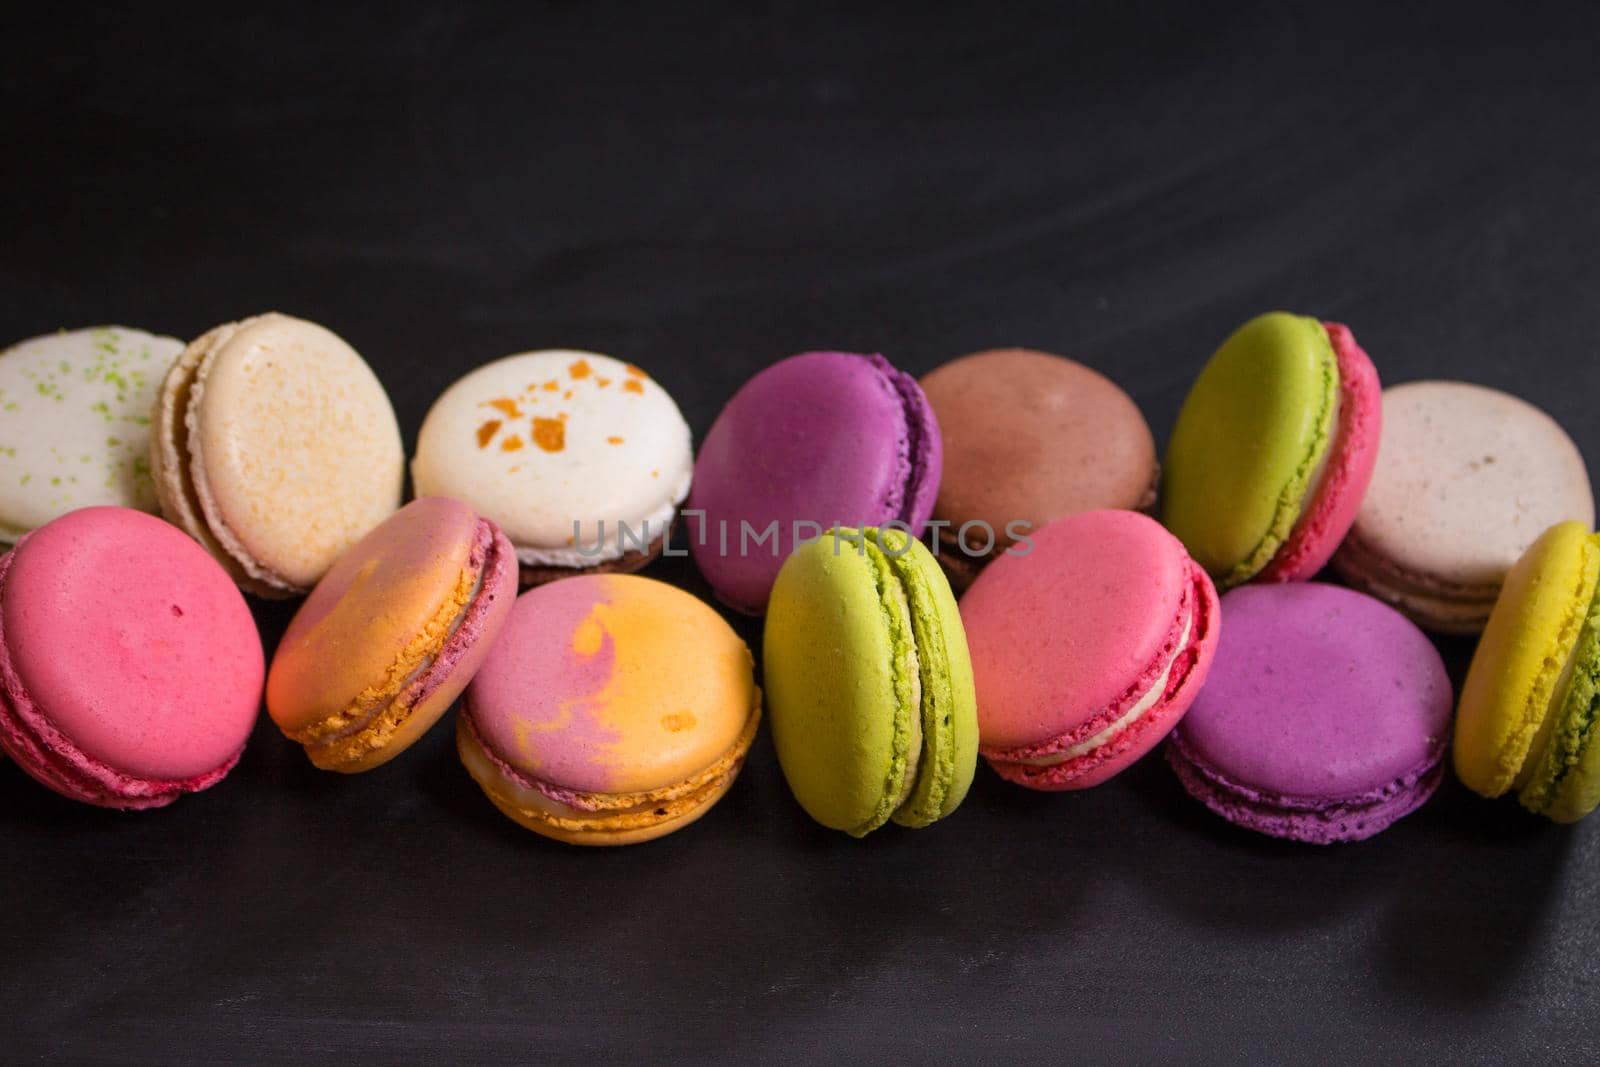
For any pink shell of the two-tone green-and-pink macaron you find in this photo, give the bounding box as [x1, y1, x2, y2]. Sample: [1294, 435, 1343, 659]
[1261, 322, 1382, 582]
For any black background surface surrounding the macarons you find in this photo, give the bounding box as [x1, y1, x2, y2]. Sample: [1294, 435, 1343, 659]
[0, 3, 1600, 1062]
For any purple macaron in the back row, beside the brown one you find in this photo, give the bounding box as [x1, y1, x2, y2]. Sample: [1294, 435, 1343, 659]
[685, 352, 944, 614]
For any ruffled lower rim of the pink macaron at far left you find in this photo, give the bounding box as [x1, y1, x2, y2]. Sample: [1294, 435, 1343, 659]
[0, 550, 243, 809]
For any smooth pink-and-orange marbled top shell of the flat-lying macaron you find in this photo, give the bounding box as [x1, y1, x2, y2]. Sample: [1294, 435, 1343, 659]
[467, 574, 758, 793]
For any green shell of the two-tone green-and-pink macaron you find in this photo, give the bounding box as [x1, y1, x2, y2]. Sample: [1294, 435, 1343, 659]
[1162, 312, 1339, 587]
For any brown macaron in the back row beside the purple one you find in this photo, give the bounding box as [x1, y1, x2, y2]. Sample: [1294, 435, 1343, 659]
[922, 349, 1160, 589]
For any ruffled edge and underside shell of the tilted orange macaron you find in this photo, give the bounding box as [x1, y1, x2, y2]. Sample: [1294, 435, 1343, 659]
[290, 518, 512, 769]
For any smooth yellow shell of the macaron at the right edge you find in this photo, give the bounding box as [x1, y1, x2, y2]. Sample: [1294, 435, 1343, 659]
[1453, 522, 1600, 797]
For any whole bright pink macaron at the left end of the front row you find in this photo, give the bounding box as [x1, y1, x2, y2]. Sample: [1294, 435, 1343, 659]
[0, 507, 266, 809]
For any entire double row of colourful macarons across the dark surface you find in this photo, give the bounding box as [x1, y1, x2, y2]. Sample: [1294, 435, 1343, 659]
[0, 314, 1595, 841]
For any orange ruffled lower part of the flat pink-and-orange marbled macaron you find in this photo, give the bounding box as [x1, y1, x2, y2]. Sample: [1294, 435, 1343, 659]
[456, 701, 762, 835]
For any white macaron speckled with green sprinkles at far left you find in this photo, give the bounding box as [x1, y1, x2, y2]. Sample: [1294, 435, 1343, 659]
[0, 326, 184, 544]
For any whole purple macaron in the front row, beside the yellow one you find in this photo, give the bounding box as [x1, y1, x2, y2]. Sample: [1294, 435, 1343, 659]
[1166, 582, 1451, 845]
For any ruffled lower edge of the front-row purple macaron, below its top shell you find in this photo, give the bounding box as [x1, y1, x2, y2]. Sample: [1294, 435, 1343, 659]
[1166, 731, 1445, 845]
